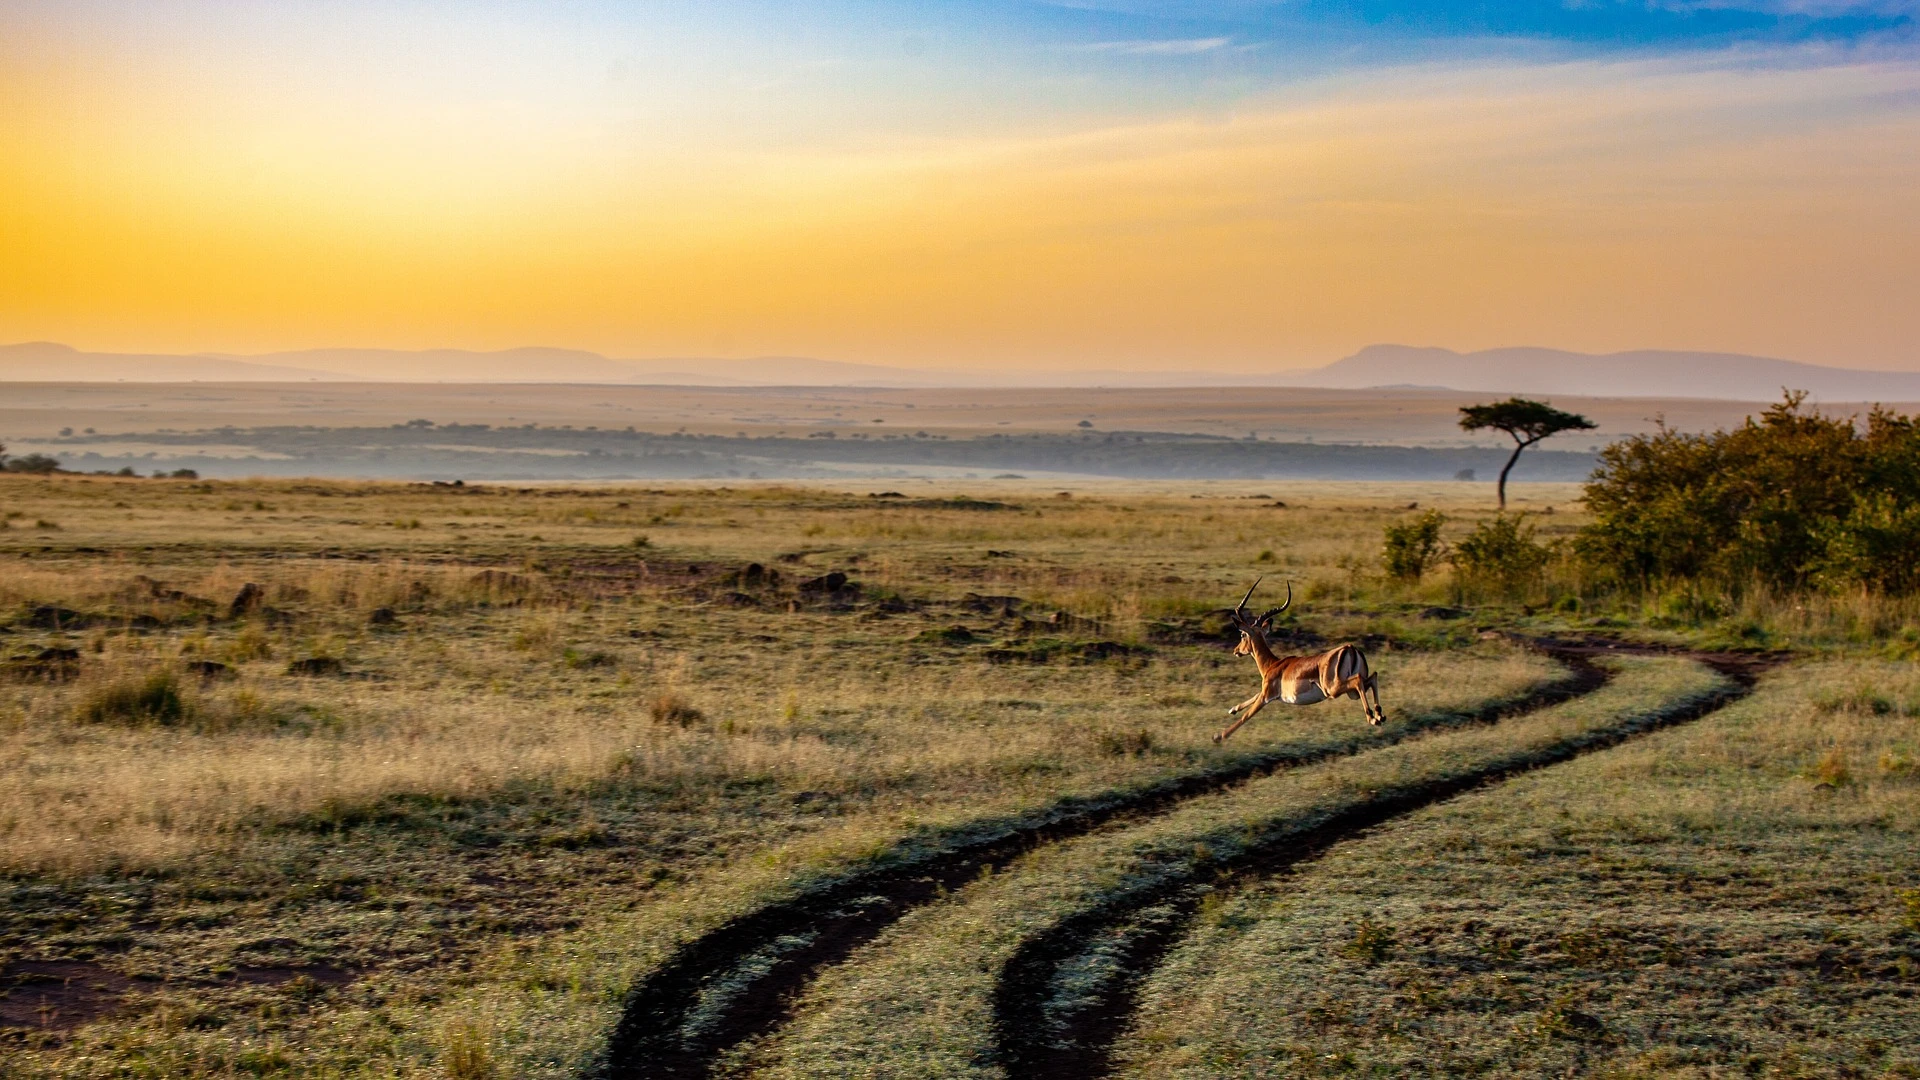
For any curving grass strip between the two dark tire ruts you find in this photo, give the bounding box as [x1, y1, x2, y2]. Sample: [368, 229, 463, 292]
[760, 661, 1716, 1076]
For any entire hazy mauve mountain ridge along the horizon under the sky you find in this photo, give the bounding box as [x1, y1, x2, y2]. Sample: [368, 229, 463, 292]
[0, 342, 1920, 402]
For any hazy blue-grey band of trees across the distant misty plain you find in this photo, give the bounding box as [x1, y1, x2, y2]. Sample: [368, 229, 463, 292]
[58, 421, 1596, 480]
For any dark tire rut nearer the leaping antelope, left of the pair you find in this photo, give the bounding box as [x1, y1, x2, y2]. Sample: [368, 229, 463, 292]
[589, 642, 1611, 1080]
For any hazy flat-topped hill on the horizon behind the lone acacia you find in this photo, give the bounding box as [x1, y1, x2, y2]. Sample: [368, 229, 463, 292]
[1296, 344, 1920, 402]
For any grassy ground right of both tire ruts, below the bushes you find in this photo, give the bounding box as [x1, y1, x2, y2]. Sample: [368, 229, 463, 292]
[1125, 661, 1920, 1076]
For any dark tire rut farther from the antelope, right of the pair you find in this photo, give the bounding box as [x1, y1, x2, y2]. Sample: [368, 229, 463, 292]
[993, 640, 1784, 1080]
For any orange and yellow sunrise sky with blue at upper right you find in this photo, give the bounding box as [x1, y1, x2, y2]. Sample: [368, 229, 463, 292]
[0, 0, 1920, 371]
